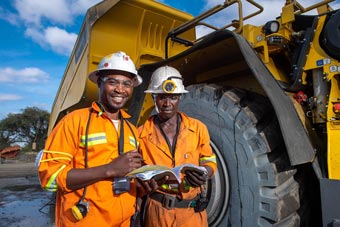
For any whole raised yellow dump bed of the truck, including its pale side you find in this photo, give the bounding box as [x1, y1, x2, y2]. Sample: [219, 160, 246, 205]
[49, 0, 195, 132]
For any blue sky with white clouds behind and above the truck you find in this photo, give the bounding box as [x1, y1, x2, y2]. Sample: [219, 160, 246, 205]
[0, 0, 340, 119]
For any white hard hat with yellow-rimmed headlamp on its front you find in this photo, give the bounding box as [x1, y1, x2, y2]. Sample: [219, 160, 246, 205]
[144, 66, 188, 94]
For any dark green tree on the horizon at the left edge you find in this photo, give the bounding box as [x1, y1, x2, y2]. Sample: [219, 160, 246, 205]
[0, 107, 50, 150]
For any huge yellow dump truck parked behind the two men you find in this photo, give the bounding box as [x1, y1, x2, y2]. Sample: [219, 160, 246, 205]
[49, 0, 340, 227]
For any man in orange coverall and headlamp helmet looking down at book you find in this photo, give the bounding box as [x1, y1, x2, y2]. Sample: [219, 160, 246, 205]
[138, 66, 217, 227]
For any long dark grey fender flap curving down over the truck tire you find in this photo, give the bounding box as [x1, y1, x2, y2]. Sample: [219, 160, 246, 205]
[233, 33, 315, 166]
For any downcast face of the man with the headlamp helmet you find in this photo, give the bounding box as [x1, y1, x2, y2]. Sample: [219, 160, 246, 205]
[155, 94, 180, 120]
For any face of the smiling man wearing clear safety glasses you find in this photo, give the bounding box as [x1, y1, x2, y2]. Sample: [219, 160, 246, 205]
[99, 72, 133, 113]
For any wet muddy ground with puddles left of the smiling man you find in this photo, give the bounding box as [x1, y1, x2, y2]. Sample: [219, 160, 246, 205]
[0, 153, 54, 227]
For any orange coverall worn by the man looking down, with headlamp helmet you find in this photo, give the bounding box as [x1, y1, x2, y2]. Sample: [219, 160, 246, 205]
[138, 113, 217, 227]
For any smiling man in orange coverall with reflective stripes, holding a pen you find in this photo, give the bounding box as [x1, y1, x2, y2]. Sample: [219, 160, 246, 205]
[39, 52, 142, 227]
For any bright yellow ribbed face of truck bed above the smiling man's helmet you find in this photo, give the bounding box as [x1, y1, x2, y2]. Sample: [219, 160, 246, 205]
[89, 0, 195, 70]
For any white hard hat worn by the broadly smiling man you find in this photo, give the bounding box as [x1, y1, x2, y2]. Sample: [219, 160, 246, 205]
[89, 51, 143, 87]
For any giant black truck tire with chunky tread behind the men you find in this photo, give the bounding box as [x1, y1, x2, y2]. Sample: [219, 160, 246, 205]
[179, 84, 300, 227]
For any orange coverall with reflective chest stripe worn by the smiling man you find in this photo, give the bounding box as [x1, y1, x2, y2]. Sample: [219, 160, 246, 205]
[39, 103, 137, 227]
